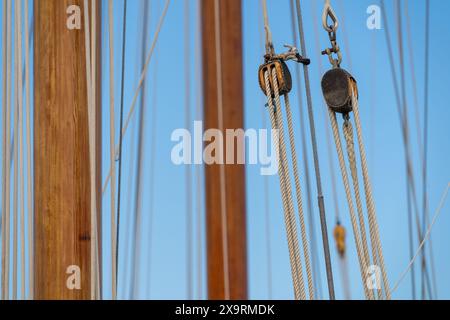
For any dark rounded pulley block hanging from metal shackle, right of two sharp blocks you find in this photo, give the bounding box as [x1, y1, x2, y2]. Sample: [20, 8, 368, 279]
[322, 68, 358, 114]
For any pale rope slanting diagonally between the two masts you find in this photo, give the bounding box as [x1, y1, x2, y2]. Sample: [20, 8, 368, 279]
[102, 0, 170, 194]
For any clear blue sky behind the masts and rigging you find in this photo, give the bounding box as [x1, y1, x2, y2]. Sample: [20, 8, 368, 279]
[0, 0, 450, 299]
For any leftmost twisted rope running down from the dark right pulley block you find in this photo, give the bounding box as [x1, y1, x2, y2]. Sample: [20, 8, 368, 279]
[328, 108, 374, 300]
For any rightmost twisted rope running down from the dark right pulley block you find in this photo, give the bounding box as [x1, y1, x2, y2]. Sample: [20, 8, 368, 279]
[352, 92, 391, 300]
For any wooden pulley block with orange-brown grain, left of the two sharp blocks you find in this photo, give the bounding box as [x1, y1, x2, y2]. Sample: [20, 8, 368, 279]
[258, 59, 292, 96]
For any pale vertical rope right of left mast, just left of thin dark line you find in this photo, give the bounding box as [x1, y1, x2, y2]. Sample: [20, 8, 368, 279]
[109, 0, 117, 300]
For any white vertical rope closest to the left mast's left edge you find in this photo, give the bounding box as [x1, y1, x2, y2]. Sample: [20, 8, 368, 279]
[24, 0, 34, 300]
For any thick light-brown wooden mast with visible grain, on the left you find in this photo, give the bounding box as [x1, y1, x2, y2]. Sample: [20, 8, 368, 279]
[34, 0, 101, 299]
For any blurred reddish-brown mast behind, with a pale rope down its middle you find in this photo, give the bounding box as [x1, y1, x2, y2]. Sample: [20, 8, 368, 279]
[201, 0, 247, 300]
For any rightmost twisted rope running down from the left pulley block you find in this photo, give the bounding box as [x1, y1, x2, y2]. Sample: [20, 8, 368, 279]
[284, 94, 315, 300]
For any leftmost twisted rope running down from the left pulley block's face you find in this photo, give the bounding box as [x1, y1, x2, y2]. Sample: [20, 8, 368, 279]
[264, 71, 305, 300]
